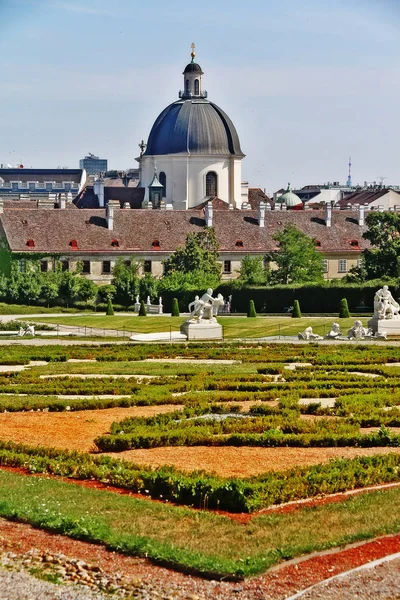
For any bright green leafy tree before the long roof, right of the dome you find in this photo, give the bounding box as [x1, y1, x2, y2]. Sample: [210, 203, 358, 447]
[266, 224, 323, 284]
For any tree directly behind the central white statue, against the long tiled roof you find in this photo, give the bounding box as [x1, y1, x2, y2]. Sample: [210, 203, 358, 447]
[164, 227, 221, 281]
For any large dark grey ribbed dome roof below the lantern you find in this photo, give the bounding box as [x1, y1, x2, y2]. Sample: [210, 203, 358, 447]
[145, 99, 244, 156]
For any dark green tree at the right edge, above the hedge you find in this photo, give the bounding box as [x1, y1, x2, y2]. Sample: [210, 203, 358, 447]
[353, 211, 400, 280]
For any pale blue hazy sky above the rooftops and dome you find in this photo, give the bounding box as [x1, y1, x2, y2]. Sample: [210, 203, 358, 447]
[0, 0, 400, 194]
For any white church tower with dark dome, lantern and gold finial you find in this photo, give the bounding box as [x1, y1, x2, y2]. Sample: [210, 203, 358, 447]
[138, 44, 244, 210]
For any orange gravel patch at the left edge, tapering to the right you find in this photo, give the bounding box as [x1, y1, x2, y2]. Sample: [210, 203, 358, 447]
[0, 404, 183, 452]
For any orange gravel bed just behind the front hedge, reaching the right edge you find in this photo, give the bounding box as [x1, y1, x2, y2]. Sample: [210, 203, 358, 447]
[108, 446, 400, 477]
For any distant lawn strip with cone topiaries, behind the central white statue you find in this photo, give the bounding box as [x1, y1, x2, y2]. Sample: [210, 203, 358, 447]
[28, 314, 362, 339]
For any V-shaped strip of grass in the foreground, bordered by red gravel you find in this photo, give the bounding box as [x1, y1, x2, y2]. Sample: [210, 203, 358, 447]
[0, 471, 400, 576]
